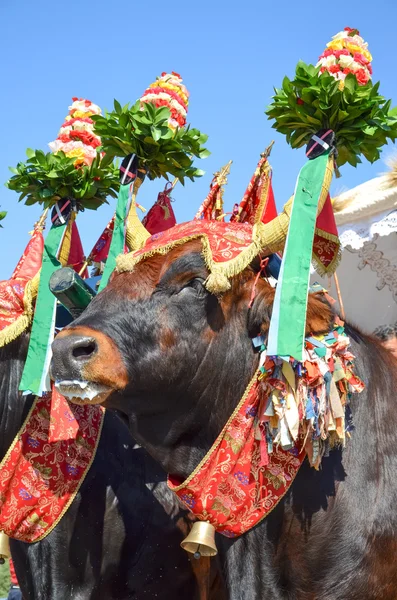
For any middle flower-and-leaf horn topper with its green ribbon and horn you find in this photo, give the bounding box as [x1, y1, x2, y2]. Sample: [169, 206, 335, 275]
[94, 72, 209, 291]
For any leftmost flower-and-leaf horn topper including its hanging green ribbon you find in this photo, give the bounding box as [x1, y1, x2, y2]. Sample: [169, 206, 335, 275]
[7, 98, 119, 396]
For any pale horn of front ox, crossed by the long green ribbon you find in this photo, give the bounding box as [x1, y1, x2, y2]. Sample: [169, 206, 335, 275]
[255, 156, 334, 254]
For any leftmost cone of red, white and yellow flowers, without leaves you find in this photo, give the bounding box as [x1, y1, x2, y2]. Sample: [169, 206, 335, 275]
[48, 98, 102, 166]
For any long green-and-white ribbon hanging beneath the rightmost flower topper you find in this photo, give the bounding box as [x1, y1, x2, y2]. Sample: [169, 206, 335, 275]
[268, 152, 329, 361]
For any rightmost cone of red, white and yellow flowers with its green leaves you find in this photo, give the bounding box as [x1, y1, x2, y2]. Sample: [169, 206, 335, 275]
[266, 28, 397, 166]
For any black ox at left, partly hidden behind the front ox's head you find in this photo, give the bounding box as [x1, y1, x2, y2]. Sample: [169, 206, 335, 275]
[0, 334, 223, 600]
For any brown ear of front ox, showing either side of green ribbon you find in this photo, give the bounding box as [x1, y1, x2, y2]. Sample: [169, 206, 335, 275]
[247, 279, 335, 337]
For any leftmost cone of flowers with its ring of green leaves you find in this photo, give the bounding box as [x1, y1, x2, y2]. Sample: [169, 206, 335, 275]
[6, 98, 120, 210]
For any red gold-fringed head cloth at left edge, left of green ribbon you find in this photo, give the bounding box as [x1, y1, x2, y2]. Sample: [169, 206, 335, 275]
[0, 230, 44, 345]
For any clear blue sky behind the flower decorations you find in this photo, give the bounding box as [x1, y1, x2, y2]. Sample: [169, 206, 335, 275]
[0, 0, 397, 279]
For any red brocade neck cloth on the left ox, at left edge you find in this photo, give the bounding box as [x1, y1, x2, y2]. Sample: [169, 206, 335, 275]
[0, 392, 104, 542]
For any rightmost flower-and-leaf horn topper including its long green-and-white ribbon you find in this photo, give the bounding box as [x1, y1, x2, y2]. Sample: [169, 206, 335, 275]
[266, 28, 397, 360]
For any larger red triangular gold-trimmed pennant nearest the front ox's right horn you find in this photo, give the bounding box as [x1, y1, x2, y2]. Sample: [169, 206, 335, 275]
[230, 157, 277, 225]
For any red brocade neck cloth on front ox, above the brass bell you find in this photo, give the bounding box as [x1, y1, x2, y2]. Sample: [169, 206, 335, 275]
[168, 375, 305, 537]
